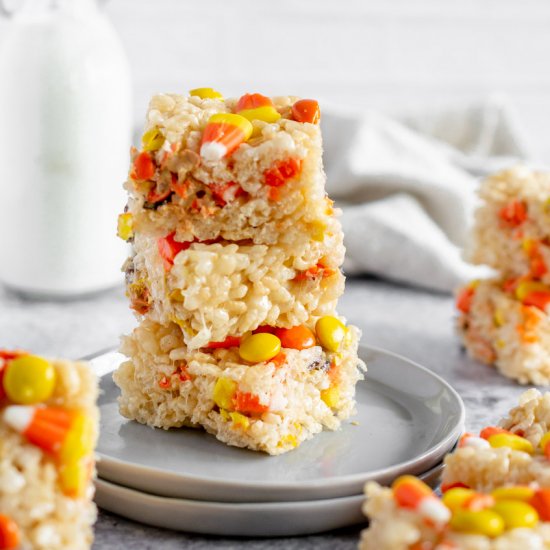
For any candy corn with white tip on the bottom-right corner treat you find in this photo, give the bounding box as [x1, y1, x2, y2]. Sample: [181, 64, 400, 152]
[392, 476, 451, 525]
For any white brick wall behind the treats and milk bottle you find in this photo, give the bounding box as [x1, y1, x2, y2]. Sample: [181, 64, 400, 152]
[0, 0, 550, 160]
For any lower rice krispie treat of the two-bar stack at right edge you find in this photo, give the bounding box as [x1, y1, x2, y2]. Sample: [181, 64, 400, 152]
[457, 277, 550, 384]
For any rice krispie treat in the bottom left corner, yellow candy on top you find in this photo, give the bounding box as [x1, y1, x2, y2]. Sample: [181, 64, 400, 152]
[0, 350, 98, 550]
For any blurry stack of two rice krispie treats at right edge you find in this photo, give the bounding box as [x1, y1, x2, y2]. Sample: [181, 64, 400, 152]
[457, 167, 550, 384]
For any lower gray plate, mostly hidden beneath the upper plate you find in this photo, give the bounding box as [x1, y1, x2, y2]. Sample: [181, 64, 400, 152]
[96, 463, 443, 537]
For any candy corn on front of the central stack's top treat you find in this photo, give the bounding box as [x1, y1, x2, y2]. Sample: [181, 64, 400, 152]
[200, 113, 253, 162]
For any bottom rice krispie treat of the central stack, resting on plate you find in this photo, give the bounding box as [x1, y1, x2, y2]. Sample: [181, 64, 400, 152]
[114, 316, 364, 454]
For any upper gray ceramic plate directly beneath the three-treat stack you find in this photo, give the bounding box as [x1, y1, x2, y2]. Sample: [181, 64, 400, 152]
[94, 346, 464, 502]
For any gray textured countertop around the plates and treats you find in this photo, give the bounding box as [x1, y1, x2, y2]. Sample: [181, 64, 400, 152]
[0, 279, 536, 550]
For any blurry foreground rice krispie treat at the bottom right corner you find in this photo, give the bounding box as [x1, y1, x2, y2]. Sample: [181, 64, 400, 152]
[359, 476, 550, 550]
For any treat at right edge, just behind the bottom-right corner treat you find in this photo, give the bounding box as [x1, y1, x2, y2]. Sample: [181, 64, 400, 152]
[442, 389, 550, 491]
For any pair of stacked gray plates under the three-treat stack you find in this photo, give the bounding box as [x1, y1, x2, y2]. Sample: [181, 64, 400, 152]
[93, 346, 464, 537]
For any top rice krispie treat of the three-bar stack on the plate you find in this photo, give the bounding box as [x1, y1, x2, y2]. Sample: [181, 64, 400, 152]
[123, 88, 340, 245]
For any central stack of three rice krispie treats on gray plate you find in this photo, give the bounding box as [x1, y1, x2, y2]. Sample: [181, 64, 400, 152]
[114, 88, 363, 454]
